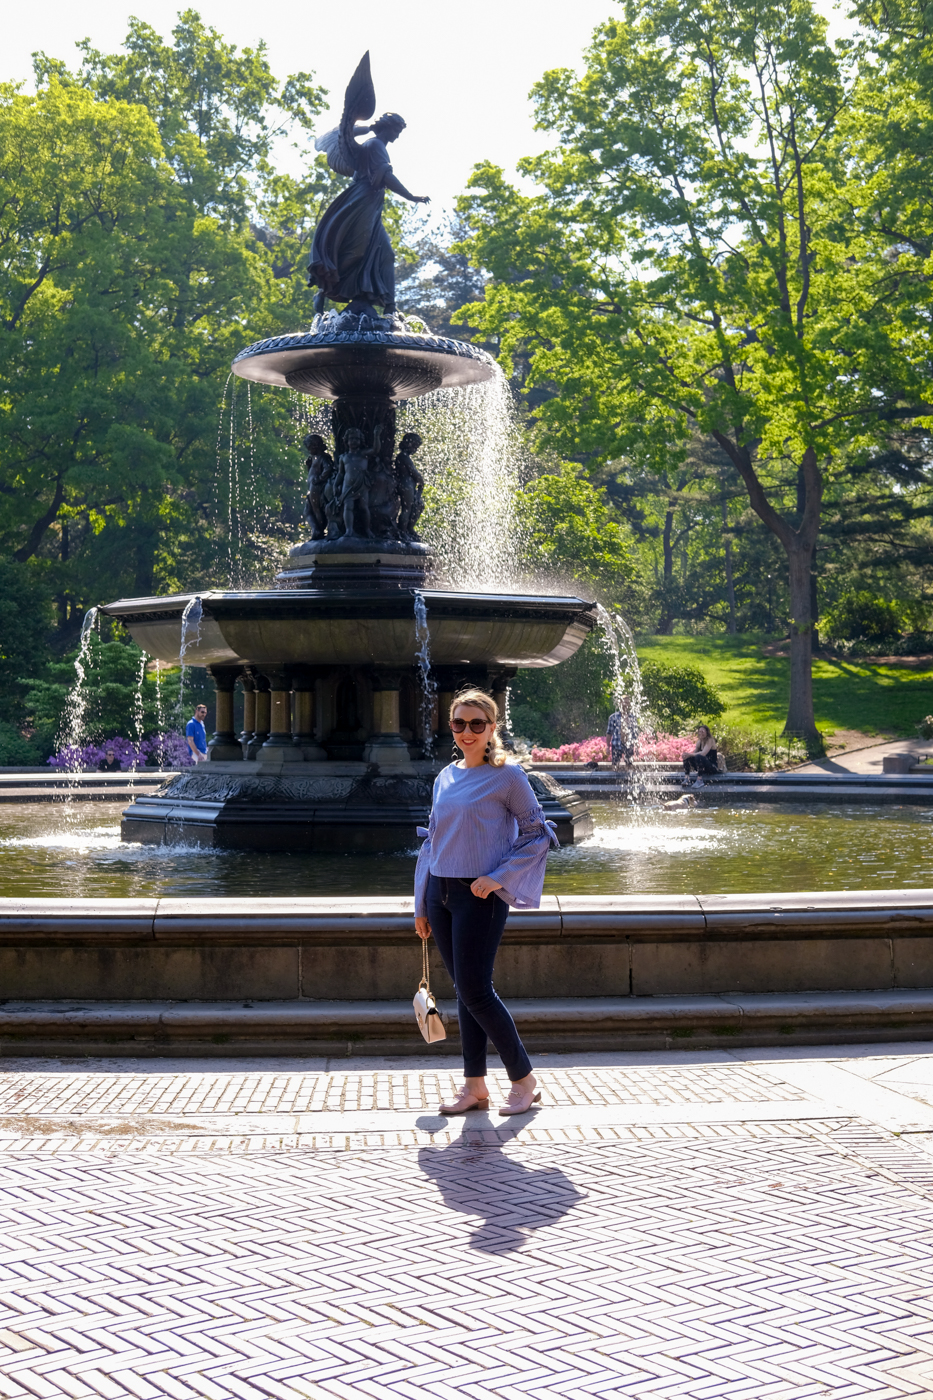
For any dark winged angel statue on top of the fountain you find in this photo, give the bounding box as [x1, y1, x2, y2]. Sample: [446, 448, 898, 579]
[308, 53, 429, 315]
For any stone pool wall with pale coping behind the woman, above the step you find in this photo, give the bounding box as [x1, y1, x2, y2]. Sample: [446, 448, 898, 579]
[0, 889, 933, 1019]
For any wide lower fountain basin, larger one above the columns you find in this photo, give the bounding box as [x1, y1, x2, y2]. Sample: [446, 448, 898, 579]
[101, 588, 597, 666]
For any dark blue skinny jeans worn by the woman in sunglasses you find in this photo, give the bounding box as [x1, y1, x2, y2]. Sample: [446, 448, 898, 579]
[427, 875, 531, 1082]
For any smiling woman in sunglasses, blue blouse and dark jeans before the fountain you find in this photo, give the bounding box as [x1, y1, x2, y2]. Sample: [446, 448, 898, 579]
[415, 690, 558, 1116]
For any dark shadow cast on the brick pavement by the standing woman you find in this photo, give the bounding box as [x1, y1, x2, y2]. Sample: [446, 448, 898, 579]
[417, 1114, 584, 1254]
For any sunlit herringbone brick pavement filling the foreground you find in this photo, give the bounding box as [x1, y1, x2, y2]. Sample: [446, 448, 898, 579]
[0, 1125, 933, 1400]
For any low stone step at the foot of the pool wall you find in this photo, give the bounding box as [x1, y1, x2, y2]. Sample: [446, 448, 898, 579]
[0, 990, 933, 1057]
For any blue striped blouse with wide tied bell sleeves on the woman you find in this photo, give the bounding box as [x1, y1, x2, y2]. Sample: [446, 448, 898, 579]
[415, 763, 558, 918]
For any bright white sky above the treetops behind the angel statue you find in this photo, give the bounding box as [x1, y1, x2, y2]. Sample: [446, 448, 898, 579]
[0, 0, 618, 213]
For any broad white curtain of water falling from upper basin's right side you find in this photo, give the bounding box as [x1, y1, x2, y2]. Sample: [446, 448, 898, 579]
[398, 368, 524, 591]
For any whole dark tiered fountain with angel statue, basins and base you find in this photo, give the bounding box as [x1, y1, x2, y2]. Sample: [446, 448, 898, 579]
[104, 55, 597, 851]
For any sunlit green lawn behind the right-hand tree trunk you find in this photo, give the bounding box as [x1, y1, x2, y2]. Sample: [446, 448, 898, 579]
[637, 633, 933, 736]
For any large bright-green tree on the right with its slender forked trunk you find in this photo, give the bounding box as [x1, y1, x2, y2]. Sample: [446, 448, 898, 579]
[461, 0, 933, 738]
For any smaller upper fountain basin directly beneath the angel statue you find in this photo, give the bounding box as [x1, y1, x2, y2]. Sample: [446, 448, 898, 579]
[233, 316, 496, 399]
